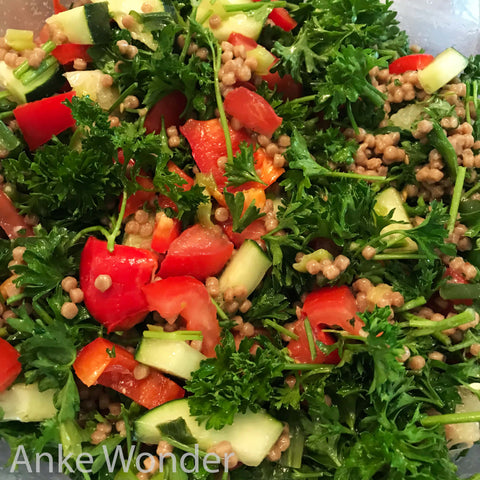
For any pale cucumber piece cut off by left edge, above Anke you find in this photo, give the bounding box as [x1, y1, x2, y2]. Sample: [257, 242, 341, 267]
[0, 383, 57, 422]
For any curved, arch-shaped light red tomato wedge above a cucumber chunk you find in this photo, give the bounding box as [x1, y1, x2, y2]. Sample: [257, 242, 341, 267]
[143, 276, 220, 357]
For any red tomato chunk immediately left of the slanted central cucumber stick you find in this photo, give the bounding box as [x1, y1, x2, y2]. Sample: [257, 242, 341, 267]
[159, 225, 233, 281]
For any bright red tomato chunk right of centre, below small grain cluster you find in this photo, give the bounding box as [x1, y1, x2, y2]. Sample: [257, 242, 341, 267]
[302, 286, 364, 335]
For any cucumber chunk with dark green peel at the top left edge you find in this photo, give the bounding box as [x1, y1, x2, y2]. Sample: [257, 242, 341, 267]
[47, 2, 111, 45]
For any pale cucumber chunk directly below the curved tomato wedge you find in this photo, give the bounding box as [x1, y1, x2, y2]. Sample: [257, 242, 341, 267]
[135, 338, 207, 380]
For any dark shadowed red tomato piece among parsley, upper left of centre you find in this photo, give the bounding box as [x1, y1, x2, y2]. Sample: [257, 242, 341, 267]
[144, 90, 187, 134]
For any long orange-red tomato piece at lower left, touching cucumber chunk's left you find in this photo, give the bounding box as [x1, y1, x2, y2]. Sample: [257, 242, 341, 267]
[73, 338, 185, 409]
